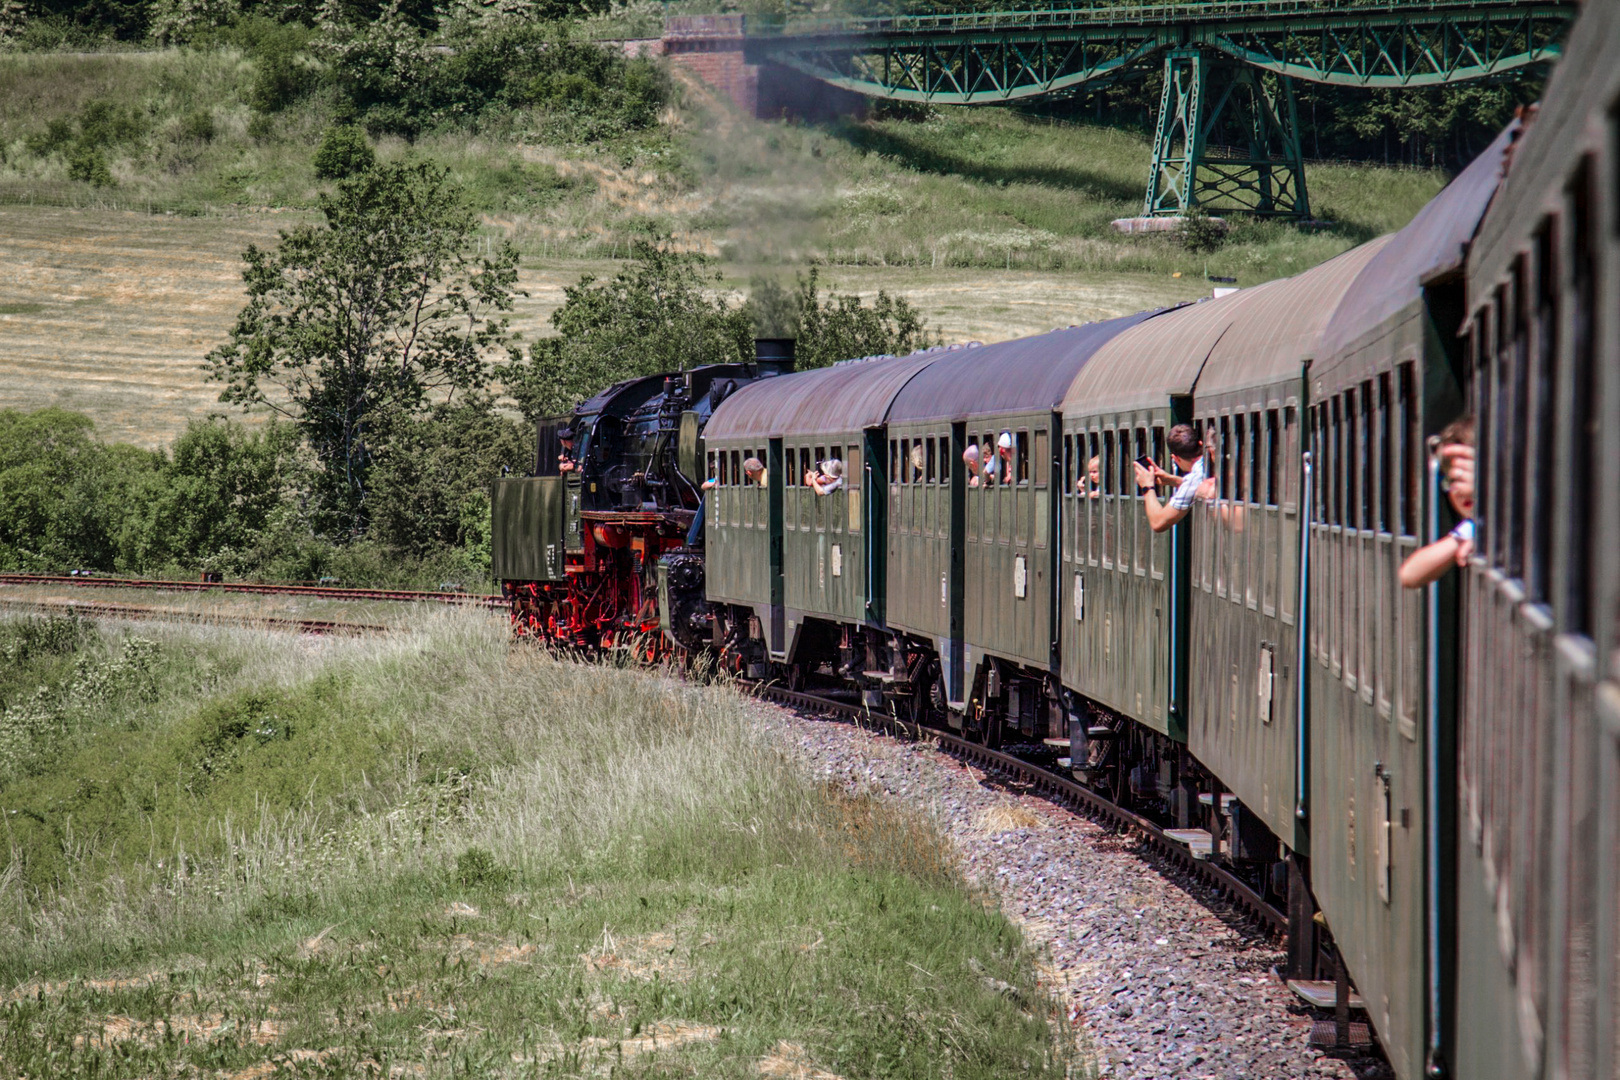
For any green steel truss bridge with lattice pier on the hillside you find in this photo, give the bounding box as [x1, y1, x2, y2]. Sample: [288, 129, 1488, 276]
[745, 0, 1581, 219]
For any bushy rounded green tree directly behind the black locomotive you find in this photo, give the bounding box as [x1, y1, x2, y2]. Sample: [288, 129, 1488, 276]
[507, 236, 753, 419]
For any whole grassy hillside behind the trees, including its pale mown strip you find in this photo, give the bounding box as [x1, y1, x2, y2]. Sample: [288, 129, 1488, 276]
[0, 47, 1443, 445]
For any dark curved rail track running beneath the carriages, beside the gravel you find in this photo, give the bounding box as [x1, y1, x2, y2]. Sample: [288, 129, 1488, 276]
[755, 683, 1288, 939]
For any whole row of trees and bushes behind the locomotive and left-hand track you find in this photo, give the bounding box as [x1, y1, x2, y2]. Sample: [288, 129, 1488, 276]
[0, 160, 935, 586]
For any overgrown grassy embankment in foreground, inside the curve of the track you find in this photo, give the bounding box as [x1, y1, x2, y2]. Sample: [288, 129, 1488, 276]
[0, 612, 1090, 1080]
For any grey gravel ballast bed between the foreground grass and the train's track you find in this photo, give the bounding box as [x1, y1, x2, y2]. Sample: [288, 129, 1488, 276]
[761, 706, 1392, 1080]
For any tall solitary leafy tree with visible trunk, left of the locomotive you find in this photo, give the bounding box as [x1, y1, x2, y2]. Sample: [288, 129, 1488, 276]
[207, 162, 517, 536]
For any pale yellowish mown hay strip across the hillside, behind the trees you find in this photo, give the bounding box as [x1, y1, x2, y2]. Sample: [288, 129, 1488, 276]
[0, 206, 1202, 447]
